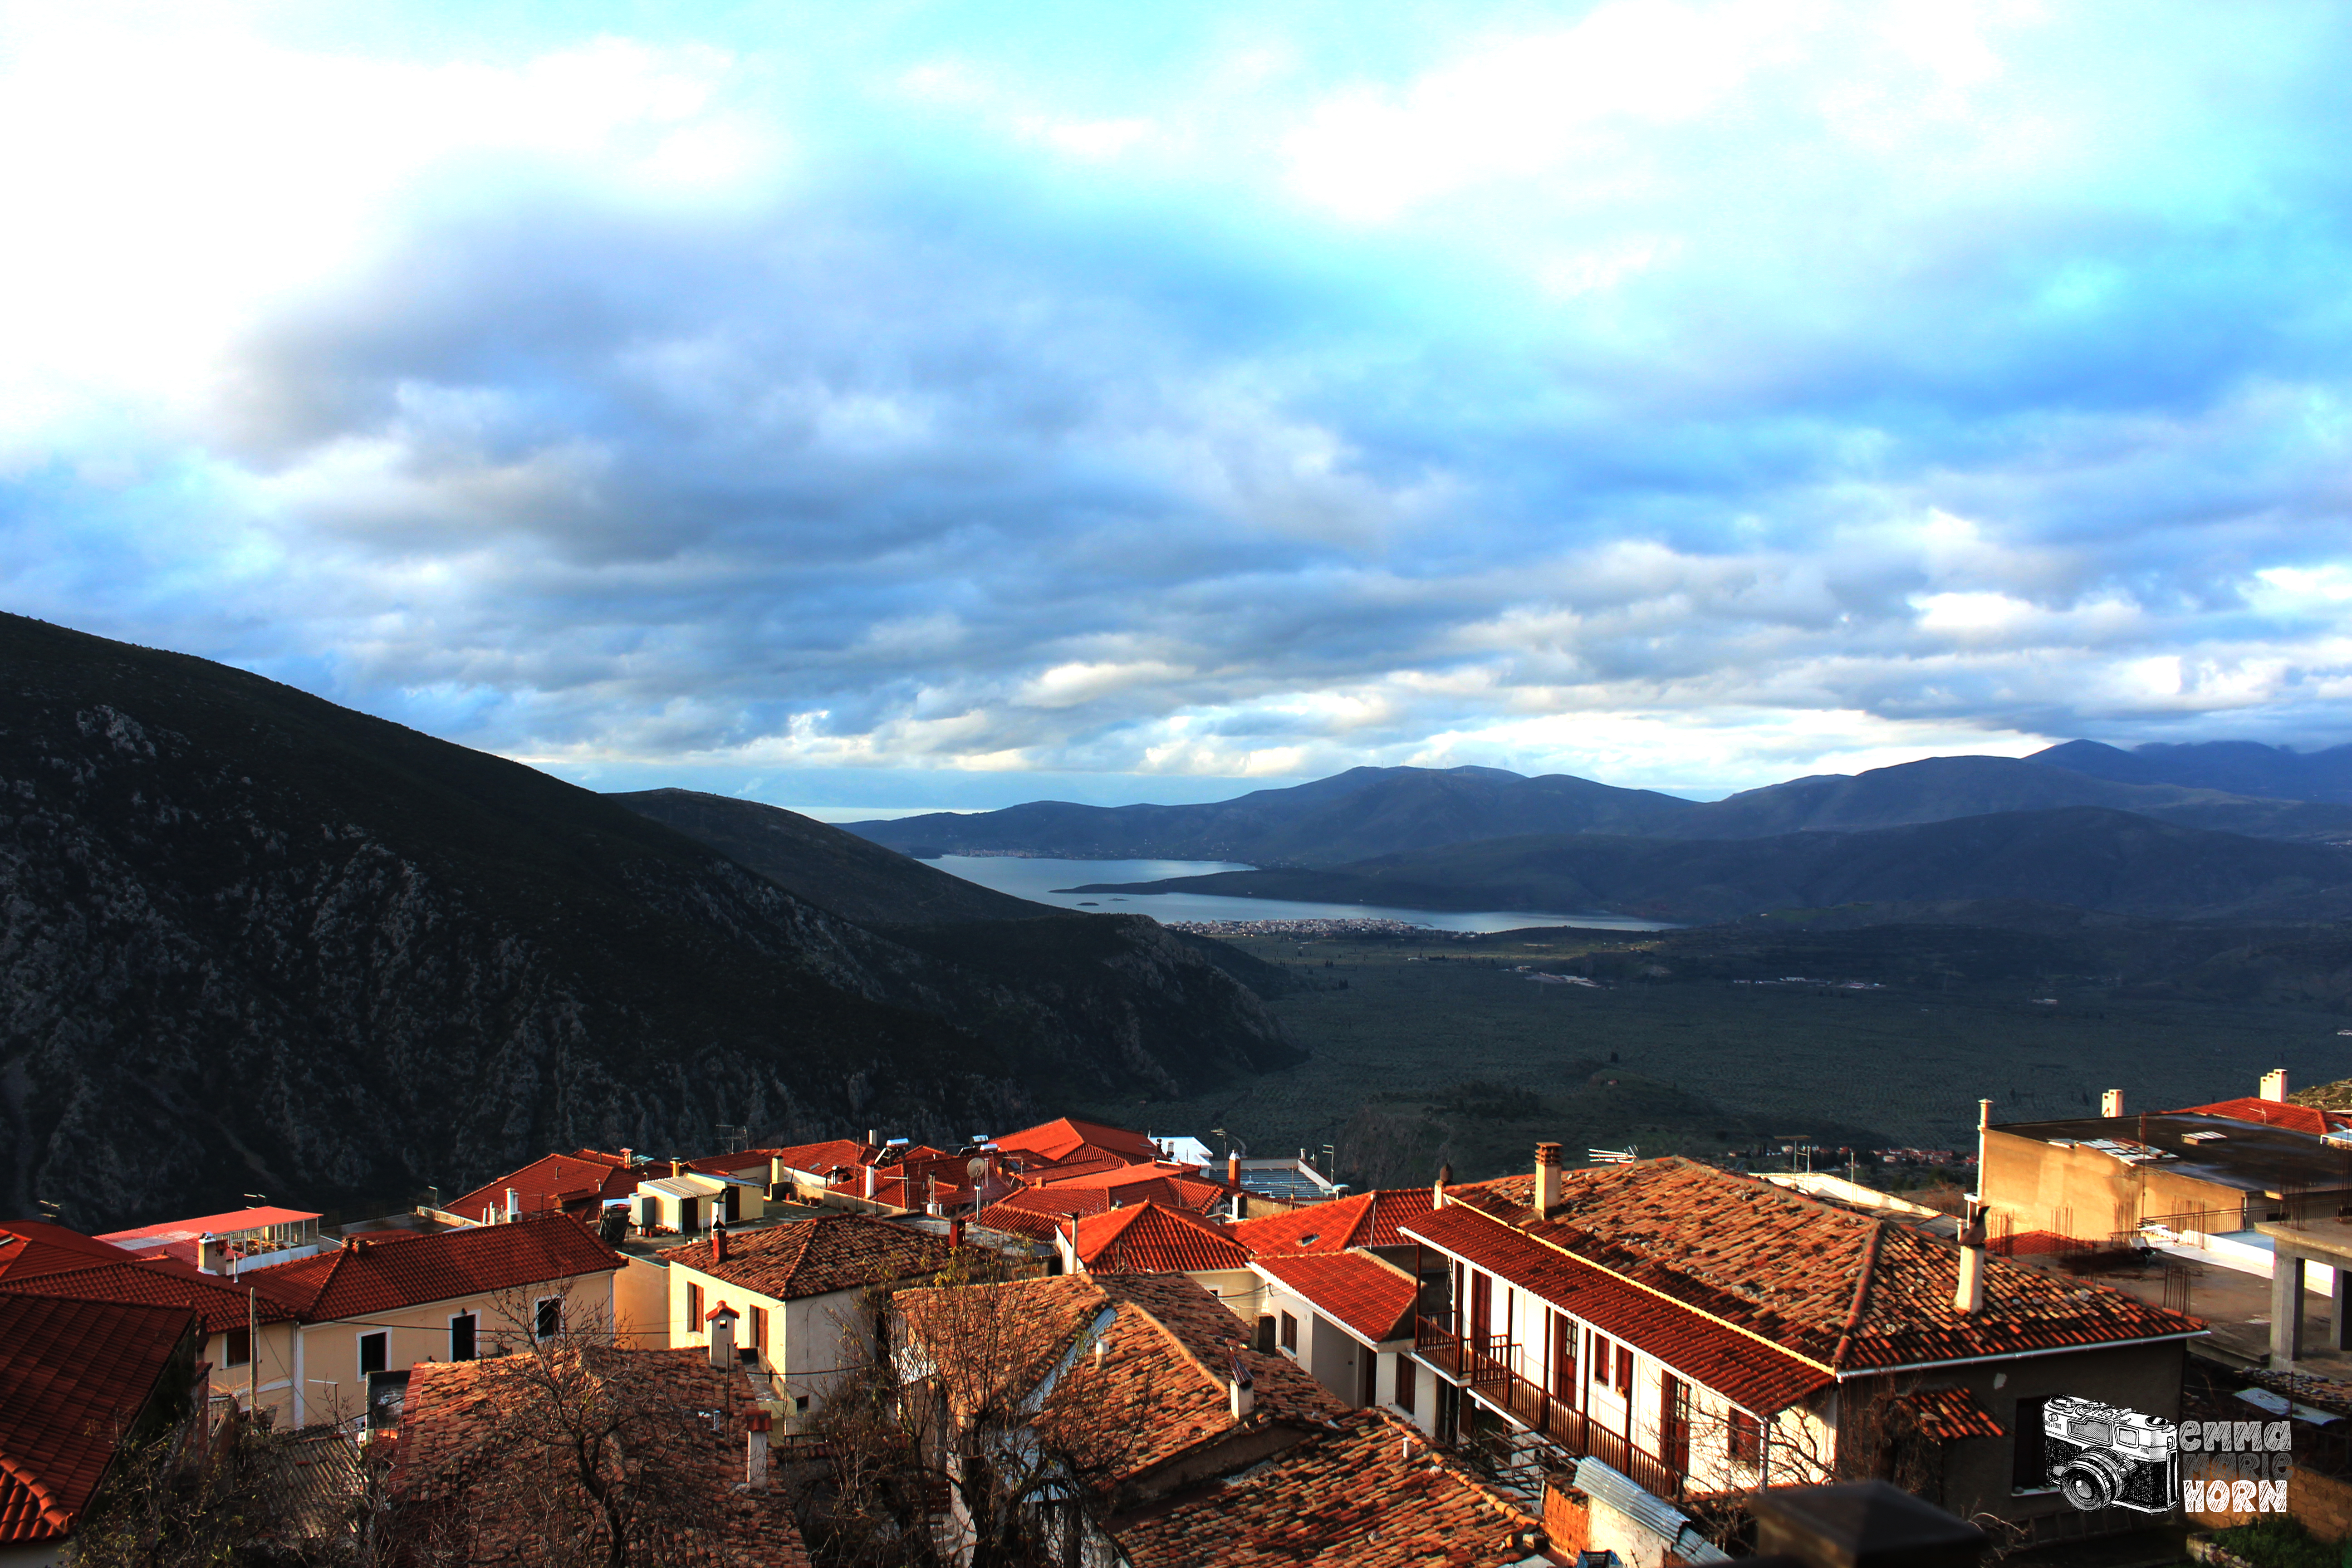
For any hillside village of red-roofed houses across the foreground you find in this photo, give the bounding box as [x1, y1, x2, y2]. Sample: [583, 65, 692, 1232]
[14, 1074, 2352, 1568]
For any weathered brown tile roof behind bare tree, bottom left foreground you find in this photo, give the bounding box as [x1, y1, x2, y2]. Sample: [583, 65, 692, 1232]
[391, 1347, 809, 1568]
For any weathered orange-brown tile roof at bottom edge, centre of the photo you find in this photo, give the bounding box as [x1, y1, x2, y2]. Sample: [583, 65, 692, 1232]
[1112, 1411, 1541, 1568]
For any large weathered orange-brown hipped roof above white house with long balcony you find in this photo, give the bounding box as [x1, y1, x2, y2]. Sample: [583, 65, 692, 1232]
[1409, 1159, 2204, 1375]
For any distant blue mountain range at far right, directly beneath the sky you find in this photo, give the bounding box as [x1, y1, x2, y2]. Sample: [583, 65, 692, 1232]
[1663, 757, 2352, 842]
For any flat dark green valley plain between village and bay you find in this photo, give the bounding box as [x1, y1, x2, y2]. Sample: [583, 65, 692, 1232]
[1087, 929, 2352, 1185]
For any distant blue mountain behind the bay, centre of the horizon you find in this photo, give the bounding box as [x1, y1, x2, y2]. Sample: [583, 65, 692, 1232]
[849, 766, 1691, 865]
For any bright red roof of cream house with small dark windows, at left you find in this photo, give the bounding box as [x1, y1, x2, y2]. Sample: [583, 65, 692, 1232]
[257, 1213, 626, 1323]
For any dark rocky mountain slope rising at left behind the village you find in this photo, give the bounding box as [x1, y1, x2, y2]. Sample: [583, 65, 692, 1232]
[0, 616, 1296, 1230]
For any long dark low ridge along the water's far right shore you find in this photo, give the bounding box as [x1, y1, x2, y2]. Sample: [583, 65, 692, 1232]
[1079, 806, 2352, 921]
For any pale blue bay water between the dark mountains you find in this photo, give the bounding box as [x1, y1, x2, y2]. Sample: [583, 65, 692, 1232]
[926, 856, 1672, 931]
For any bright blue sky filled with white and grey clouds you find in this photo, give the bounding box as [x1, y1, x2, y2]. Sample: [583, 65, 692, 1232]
[0, 0, 2352, 818]
